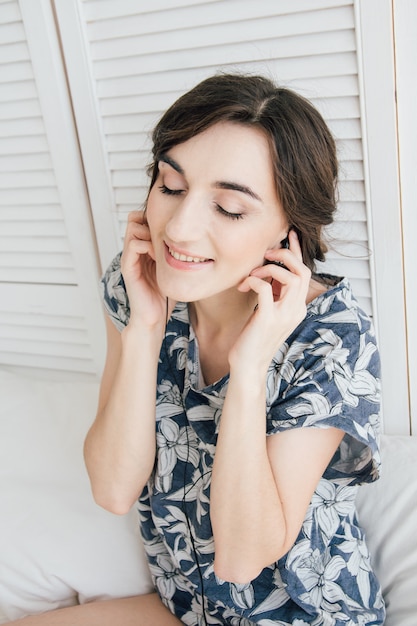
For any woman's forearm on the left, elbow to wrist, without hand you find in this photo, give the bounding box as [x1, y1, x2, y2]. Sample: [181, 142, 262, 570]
[84, 319, 161, 514]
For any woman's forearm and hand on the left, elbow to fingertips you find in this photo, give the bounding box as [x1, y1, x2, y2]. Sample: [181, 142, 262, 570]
[85, 211, 169, 513]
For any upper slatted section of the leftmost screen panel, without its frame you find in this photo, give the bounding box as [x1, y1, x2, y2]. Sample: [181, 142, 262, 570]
[0, 2, 77, 285]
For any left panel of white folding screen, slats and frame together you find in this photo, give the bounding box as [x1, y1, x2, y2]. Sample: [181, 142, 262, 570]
[0, 0, 103, 375]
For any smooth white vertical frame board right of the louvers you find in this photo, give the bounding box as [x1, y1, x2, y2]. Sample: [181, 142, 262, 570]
[356, 0, 408, 434]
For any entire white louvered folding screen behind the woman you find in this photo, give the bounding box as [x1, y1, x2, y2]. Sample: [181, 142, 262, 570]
[0, 0, 409, 433]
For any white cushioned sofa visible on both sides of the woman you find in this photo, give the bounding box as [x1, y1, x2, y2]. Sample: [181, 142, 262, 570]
[0, 370, 417, 626]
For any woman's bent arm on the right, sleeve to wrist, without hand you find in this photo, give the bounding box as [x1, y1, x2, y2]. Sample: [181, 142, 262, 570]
[210, 376, 343, 584]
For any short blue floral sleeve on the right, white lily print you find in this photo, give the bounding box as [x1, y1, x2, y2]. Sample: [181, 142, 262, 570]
[267, 294, 380, 485]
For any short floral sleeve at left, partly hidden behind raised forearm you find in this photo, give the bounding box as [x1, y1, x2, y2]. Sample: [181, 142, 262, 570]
[100, 252, 130, 331]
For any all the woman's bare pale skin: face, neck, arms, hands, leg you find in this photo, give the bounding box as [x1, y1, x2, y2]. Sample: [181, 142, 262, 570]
[5, 123, 343, 626]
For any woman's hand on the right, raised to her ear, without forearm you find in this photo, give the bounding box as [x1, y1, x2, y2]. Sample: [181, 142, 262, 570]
[229, 230, 311, 373]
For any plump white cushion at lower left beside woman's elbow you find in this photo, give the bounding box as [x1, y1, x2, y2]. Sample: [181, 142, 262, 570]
[0, 370, 152, 623]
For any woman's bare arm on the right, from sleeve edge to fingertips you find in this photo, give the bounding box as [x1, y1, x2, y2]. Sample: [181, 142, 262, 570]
[210, 231, 343, 583]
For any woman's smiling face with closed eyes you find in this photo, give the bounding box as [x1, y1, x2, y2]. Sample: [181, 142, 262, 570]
[147, 122, 288, 302]
